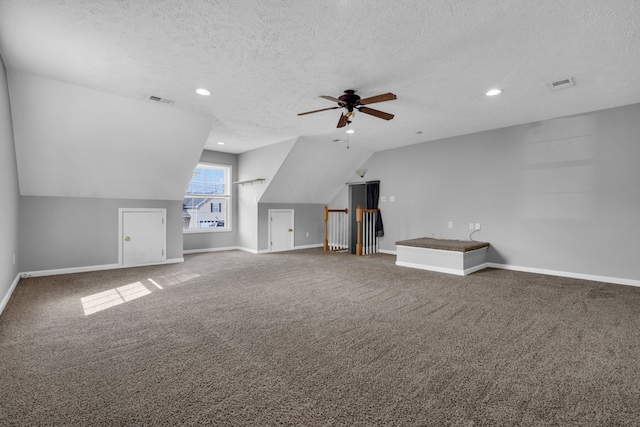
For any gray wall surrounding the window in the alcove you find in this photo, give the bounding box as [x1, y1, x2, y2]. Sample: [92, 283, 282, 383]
[183, 150, 238, 251]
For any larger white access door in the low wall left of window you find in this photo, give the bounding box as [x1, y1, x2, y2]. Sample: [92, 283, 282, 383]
[120, 209, 167, 266]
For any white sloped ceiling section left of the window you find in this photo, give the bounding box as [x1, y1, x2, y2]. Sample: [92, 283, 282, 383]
[9, 72, 211, 200]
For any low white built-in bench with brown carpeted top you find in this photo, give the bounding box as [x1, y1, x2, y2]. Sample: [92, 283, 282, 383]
[396, 237, 489, 276]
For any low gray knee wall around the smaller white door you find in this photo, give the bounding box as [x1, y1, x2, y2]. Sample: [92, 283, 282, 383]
[258, 203, 325, 251]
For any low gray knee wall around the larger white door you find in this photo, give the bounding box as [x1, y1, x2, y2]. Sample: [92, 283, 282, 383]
[18, 196, 182, 272]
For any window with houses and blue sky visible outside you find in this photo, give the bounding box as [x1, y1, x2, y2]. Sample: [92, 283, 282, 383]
[182, 163, 231, 232]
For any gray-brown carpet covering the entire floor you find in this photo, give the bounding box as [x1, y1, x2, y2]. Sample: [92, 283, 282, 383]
[0, 249, 640, 426]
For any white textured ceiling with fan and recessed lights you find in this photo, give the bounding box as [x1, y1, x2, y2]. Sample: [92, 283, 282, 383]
[0, 0, 640, 153]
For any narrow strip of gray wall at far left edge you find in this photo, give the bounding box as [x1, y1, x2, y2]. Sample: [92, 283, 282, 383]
[0, 58, 21, 312]
